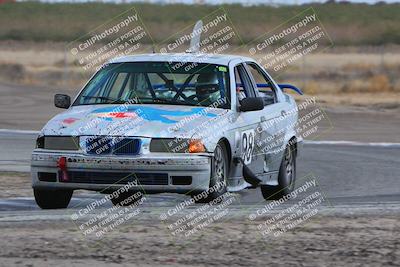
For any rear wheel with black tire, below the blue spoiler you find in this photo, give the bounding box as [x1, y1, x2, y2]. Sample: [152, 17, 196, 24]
[260, 146, 297, 200]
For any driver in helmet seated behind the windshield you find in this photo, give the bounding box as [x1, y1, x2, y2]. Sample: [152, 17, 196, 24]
[195, 72, 220, 106]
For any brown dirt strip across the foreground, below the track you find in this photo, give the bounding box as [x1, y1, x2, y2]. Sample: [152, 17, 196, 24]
[0, 214, 400, 266]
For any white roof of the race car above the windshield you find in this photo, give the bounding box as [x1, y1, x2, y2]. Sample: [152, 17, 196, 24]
[109, 53, 254, 65]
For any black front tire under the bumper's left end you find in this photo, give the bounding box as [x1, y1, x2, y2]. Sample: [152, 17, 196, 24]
[33, 188, 73, 209]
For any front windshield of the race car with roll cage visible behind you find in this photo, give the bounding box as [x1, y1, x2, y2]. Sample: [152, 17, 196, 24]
[74, 62, 230, 108]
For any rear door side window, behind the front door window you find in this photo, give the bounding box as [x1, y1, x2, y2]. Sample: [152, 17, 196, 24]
[247, 63, 276, 105]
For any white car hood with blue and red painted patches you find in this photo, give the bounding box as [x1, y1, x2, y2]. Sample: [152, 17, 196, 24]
[41, 104, 231, 138]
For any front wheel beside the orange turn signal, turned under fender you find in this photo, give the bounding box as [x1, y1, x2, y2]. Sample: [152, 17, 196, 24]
[192, 142, 229, 203]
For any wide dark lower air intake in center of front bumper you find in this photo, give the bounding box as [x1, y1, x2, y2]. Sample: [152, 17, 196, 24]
[61, 171, 168, 185]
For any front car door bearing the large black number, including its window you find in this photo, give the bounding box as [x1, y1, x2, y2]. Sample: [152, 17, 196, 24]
[235, 64, 266, 178]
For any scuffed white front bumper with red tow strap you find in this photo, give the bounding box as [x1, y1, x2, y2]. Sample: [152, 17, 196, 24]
[31, 149, 212, 193]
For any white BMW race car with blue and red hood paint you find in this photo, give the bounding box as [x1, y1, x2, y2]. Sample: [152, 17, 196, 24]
[31, 53, 299, 208]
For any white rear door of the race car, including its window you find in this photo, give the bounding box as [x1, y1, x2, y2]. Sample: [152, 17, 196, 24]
[246, 62, 286, 173]
